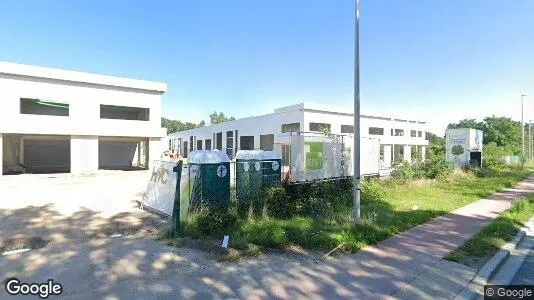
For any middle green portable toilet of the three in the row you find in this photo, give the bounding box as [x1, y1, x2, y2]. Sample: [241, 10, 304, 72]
[235, 150, 262, 201]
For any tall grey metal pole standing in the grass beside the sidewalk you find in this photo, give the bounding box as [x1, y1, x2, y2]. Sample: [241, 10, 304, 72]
[352, 0, 361, 224]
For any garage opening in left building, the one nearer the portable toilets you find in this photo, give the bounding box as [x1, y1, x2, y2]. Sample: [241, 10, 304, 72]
[98, 137, 149, 171]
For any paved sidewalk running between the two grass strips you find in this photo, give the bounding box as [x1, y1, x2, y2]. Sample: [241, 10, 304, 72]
[279, 177, 534, 299]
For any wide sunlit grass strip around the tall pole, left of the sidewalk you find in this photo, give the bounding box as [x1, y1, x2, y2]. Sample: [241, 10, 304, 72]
[182, 169, 532, 252]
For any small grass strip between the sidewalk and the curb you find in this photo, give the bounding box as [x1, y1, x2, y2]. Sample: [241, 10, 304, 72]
[445, 196, 534, 268]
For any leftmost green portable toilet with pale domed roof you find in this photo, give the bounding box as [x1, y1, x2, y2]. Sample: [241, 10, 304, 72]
[187, 150, 230, 207]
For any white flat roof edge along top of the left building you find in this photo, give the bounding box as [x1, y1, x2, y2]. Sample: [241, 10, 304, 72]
[0, 61, 167, 93]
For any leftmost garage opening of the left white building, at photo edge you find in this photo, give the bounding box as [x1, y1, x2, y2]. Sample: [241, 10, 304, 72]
[2, 134, 70, 175]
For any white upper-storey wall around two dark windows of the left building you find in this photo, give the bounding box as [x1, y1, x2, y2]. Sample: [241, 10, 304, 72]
[0, 74, 166, 138]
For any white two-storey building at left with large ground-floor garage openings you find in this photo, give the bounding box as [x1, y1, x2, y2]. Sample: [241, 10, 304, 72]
[0, 62, 167, 177]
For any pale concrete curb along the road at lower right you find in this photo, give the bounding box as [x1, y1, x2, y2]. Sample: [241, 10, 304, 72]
[456, 217, 534, 299]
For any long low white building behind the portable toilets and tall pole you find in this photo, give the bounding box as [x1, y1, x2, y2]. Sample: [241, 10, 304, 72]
[169, 103, 428, 168]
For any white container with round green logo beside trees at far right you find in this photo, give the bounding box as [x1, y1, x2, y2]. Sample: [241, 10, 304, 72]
[445, 128, 484, 168]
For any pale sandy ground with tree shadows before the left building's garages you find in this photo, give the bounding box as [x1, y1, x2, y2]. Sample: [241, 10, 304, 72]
[0, 171, 336, 299]
